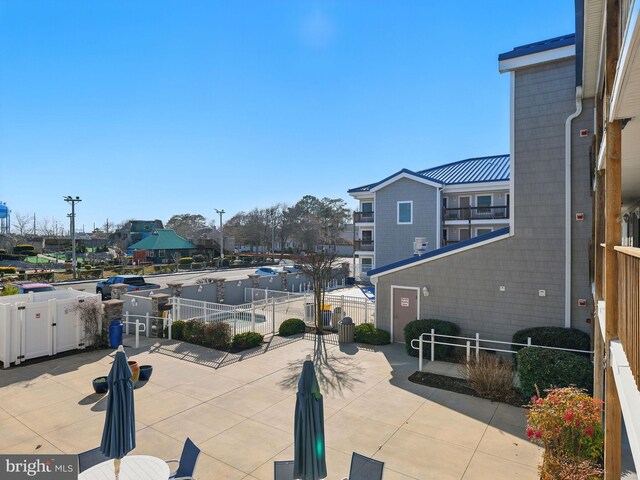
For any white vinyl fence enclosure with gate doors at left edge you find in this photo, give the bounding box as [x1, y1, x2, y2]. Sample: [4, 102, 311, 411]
[0, 290, 100, 368]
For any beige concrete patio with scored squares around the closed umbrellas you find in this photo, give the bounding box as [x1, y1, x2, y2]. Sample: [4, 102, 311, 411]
[0, 337, 542, 480]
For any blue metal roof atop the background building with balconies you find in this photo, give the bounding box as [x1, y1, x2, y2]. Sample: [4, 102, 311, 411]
[347, 155, 510, 193]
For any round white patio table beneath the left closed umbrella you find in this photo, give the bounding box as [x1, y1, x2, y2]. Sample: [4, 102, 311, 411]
[78, 455, 171, 480]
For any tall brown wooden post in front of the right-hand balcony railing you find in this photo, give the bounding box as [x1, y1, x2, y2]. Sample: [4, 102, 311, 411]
[603, 0, 622, 480]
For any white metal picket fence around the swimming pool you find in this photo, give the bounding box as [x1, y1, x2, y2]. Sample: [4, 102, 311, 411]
[170, 288, 375, 335]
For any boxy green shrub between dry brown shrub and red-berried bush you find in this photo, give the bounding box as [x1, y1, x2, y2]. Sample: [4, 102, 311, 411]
[518, 347, 593, 397]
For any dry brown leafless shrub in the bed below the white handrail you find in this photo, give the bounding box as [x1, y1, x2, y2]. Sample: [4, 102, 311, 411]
[460, 353, 515, 401]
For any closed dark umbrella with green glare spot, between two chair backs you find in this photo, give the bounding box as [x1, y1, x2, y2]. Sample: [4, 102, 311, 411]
[293, 357, 327, 480]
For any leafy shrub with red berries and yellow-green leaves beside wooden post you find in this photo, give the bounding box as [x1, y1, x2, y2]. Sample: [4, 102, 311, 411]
[527, 387, 604, 480]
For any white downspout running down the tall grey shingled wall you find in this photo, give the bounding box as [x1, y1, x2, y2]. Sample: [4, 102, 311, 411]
[564, 86, 582, 328]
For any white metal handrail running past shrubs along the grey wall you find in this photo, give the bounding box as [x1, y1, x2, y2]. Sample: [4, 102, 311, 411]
[411, 328, 593, 372]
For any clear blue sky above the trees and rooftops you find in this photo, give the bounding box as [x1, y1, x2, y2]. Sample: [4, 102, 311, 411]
[0, 0, 575, 230]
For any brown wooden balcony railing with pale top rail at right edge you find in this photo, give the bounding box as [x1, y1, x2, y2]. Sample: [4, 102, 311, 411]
[616, 247, 640, 386]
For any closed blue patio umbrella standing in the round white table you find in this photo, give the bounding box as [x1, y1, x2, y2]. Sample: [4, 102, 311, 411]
[100, 345, 136, 480]
